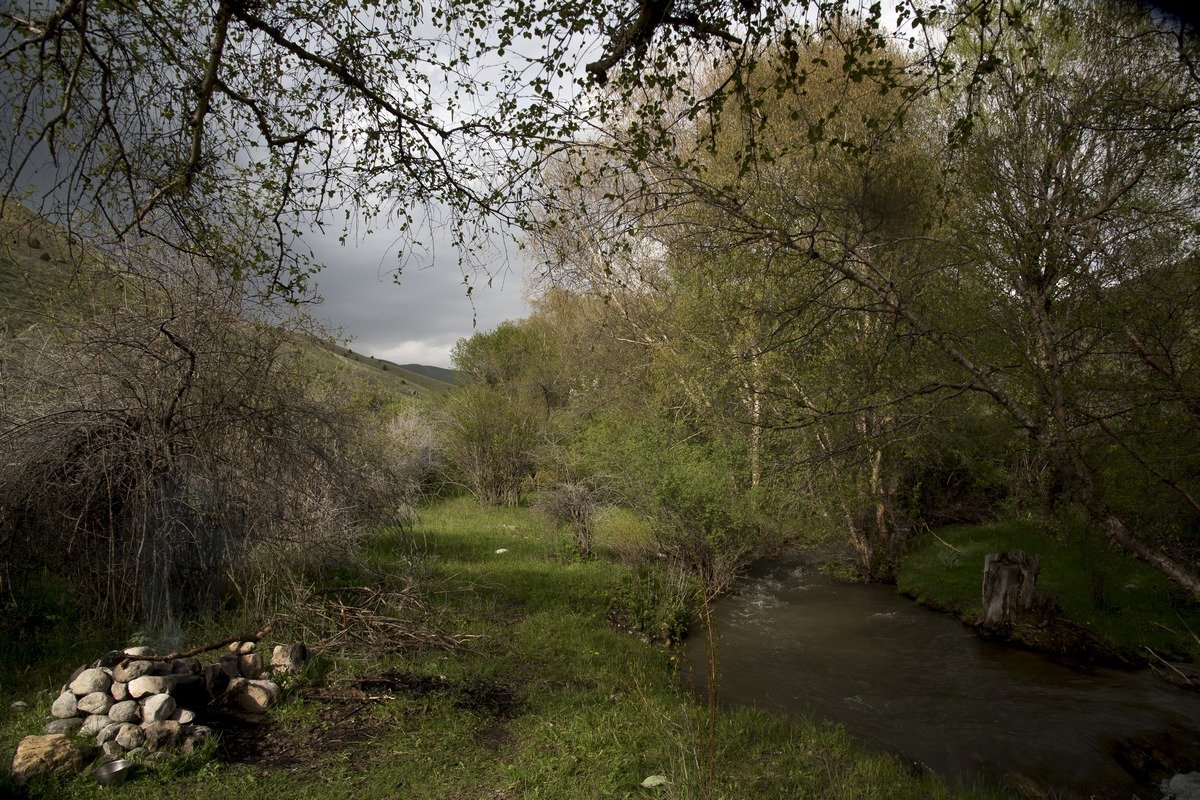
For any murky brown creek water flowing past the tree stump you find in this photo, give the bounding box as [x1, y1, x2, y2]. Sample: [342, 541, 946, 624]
[686, 564, 1200, 800]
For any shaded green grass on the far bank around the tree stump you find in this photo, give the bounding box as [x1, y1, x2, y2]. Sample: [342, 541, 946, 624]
[896, 519, 1200, 660]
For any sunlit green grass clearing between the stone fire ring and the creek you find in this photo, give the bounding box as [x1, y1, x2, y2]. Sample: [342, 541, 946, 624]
[0, 500, 1003, 800]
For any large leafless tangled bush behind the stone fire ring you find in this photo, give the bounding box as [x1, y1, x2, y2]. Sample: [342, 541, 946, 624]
[0, 252, 403, 622]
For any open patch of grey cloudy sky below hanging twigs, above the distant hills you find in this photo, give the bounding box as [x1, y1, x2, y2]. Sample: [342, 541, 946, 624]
[308, 220, 529, 367]
